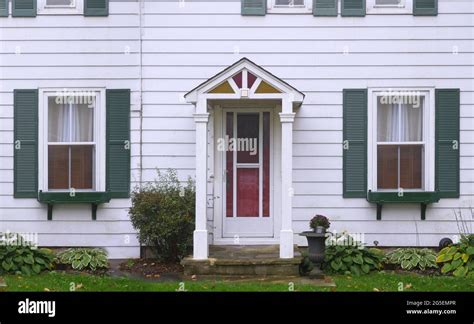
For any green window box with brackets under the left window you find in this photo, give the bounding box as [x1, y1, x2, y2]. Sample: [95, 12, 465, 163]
[38, 191, 111, 220]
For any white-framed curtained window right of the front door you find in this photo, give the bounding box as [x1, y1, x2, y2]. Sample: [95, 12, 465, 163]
[368, 90, 434, 191]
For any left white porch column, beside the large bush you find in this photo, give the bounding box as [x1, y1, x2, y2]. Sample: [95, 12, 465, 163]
[193, 104, 209, 260]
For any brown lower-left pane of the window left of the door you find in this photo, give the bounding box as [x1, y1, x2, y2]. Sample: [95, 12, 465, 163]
[48, 145, 69, 189]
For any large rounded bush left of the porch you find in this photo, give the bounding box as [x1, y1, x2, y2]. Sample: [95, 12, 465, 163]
[129, 170, 196, 262]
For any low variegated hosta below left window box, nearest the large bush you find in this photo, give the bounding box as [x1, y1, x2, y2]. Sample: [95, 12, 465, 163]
[58, 248, 109, 271]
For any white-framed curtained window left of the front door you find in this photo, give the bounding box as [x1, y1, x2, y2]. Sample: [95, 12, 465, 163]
[40, 91, 105, 191]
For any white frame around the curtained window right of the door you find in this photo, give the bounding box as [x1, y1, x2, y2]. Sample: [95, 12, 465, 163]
[367, 88, 435, 192]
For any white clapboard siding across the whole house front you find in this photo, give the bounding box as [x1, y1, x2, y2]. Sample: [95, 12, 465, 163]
[0, 0, 474, 257]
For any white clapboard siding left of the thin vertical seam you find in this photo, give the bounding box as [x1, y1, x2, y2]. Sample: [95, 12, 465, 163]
[0, 1, 140, 258]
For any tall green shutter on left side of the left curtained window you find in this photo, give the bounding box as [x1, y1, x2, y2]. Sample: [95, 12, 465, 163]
[13, 90, 38, 198]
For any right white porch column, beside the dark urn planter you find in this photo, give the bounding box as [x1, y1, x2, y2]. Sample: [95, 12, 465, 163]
[280, 99, 295, 259]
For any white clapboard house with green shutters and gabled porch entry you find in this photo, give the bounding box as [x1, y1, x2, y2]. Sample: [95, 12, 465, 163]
[0, 0, 474, 259]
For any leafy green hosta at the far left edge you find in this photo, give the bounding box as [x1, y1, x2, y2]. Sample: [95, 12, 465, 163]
[0, 233, 54, 276]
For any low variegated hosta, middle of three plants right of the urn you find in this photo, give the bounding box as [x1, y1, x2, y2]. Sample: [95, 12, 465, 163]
[385, 248, 438, 270]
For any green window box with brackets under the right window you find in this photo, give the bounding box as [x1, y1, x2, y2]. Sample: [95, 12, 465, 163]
[367, 190, 440, 220]
